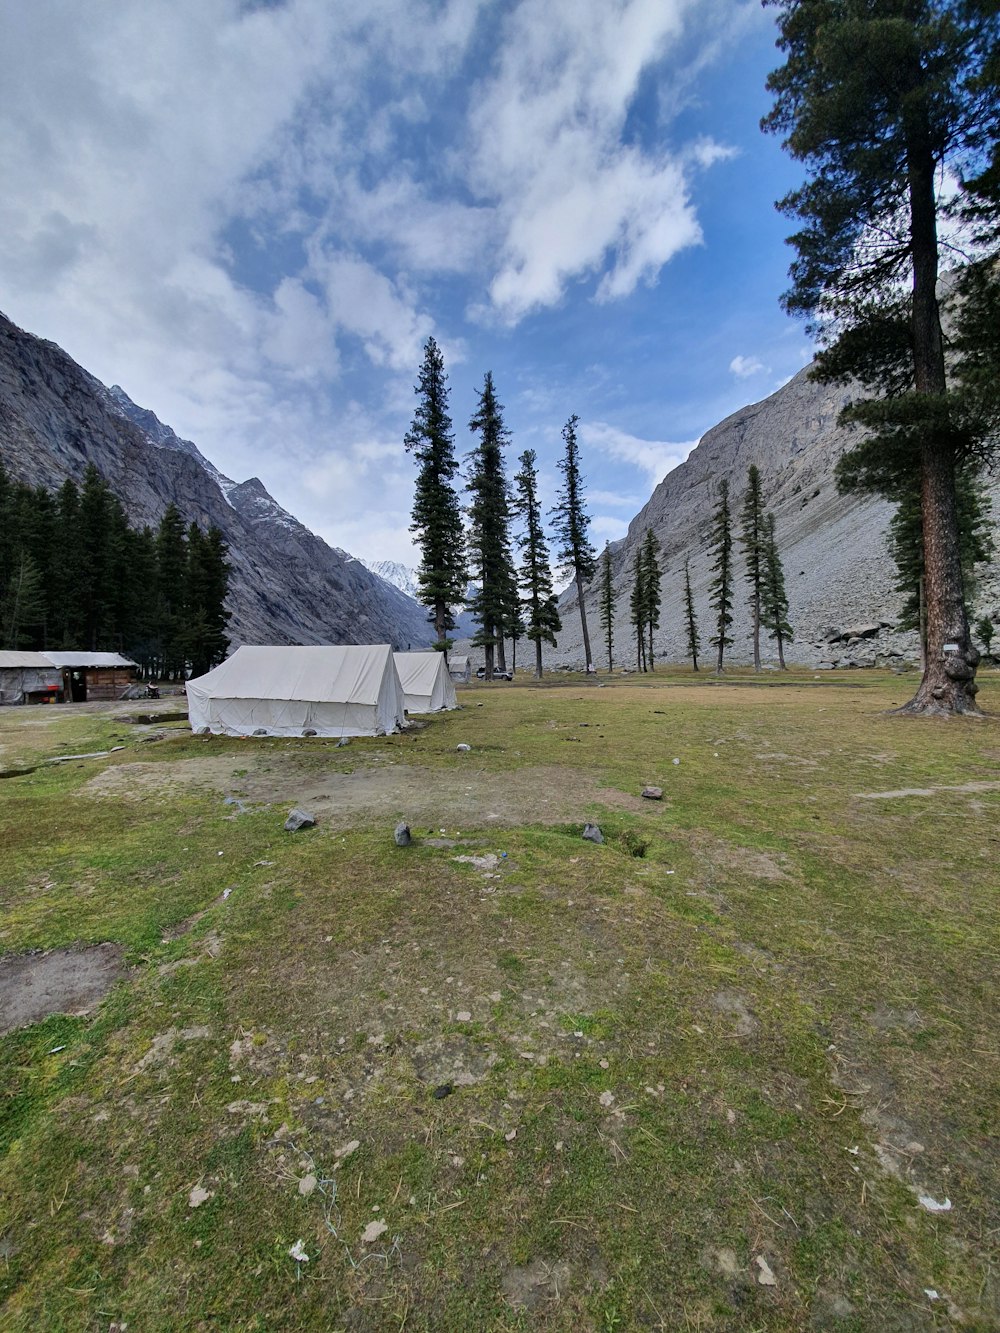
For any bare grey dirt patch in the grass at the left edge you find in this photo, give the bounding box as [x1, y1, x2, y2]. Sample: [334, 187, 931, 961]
[0, 944, 125, 1034]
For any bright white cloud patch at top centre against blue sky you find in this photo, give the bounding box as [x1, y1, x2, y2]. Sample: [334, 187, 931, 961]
[471, 0, 725, 323]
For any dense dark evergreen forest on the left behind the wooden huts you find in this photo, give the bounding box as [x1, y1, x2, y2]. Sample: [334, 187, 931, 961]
[0, 463, 229, 680]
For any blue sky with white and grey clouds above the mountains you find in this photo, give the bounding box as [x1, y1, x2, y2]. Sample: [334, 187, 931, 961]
[0, 0, 809, 563]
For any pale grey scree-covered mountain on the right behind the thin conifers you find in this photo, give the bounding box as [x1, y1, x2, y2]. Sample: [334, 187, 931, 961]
[549, 368, 1000, 667]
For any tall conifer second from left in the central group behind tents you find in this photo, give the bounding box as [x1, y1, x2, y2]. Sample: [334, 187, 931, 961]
[465, 371, 516, 681]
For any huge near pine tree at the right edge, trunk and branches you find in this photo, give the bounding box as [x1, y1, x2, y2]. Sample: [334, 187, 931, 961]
[764, 0, 1000, 713]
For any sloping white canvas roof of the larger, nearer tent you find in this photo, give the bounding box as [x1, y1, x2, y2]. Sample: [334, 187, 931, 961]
[188, 644, 392, 704]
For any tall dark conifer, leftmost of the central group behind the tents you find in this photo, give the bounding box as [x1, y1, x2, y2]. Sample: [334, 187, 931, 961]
[404, 337, 468, 656]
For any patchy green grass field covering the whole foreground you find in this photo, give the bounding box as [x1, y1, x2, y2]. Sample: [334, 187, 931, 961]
[0, 672, 1000, 1333]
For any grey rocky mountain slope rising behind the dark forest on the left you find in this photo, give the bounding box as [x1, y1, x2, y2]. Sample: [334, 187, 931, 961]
[0, 307, 432, 648]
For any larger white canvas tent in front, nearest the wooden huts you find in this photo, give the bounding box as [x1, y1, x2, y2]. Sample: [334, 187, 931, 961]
[188, 644, 404, 736]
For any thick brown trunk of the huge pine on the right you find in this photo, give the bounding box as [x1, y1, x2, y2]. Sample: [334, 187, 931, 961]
[900, 122, 979, 714]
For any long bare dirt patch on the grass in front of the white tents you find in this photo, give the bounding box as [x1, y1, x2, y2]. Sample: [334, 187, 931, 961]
[84, 753, 651, 833]
